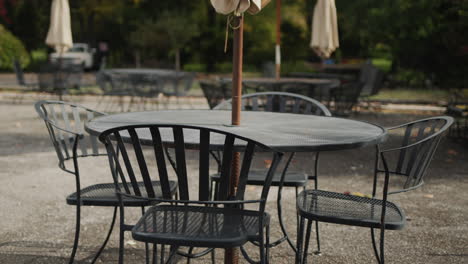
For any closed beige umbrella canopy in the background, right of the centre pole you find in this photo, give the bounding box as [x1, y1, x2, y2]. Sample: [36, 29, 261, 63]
[310, 0, 340, 58]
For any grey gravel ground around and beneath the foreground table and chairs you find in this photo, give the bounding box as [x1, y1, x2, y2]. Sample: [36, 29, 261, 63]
[0, 98, 468, 263]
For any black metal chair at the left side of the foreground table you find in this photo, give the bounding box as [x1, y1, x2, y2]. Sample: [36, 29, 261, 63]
[35, 101, 177, 263]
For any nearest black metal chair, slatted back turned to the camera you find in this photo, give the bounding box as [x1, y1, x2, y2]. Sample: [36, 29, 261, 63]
[99, 124, 282, 263]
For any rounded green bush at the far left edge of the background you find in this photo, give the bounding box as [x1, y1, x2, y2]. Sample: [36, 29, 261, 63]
[0, 25, 30, 70]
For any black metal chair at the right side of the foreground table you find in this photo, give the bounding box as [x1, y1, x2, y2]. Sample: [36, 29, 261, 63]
[296, 116, 453, 263]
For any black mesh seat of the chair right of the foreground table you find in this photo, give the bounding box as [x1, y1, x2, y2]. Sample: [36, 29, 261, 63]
[297, 190, 405, 230]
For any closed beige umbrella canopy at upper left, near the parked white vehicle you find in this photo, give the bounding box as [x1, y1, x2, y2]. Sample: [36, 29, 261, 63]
[46, 0, 73, 54]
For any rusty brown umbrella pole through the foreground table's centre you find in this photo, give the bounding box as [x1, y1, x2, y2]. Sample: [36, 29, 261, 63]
[224, 15, 244, 264]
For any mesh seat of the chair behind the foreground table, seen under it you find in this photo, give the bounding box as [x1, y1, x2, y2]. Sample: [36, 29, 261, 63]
[211, 171, 307, 187]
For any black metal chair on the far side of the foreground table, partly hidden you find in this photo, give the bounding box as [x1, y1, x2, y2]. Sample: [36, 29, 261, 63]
[211, 92, 331, 253]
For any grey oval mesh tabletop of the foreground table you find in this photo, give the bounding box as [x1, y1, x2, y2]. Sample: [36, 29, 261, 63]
[86, 110, 387, 152]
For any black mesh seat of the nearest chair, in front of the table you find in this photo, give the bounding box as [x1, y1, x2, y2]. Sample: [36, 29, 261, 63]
[132, 205, 269, 248]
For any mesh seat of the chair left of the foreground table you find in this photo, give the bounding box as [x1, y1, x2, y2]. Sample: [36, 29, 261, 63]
[67, 181, 177, 206]
